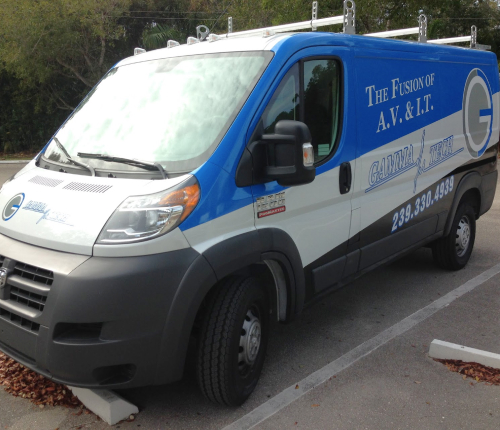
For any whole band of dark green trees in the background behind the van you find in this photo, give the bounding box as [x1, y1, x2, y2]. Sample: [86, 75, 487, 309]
[0, 0, 500, 152]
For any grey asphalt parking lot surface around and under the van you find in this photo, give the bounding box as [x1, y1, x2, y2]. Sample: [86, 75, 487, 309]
[0, 164, 500, 430]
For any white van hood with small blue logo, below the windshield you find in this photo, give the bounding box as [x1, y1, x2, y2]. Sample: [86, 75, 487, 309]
[0, 163, 189, 255]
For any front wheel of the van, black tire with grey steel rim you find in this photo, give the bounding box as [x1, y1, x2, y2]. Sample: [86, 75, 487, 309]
[197, 276, 270, 406]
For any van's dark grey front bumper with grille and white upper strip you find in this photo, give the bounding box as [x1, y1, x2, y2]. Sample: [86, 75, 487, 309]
[0, 235, 200, 388]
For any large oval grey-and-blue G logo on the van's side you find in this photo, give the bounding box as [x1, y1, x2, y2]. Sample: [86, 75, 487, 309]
[462, 69, 493, 158]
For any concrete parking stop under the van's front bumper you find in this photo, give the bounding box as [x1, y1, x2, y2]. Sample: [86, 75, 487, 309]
[68, 387, 139, 425]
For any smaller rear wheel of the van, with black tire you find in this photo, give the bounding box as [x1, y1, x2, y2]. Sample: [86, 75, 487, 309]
[432, 202, 476, 270]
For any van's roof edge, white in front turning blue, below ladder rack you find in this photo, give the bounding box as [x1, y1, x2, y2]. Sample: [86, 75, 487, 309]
[116, 32, 494, 66]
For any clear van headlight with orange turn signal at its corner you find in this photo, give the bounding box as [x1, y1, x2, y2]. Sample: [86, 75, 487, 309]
[97, 176, 200, 245]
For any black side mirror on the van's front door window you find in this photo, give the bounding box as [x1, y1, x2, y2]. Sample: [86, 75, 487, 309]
[236, 120, 316, 187]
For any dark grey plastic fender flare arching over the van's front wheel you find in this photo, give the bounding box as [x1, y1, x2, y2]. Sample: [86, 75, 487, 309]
[154, 228, 305, 385]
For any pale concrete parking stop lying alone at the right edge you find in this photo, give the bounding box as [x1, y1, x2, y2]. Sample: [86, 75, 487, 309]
[429, 339, 500, 369]
